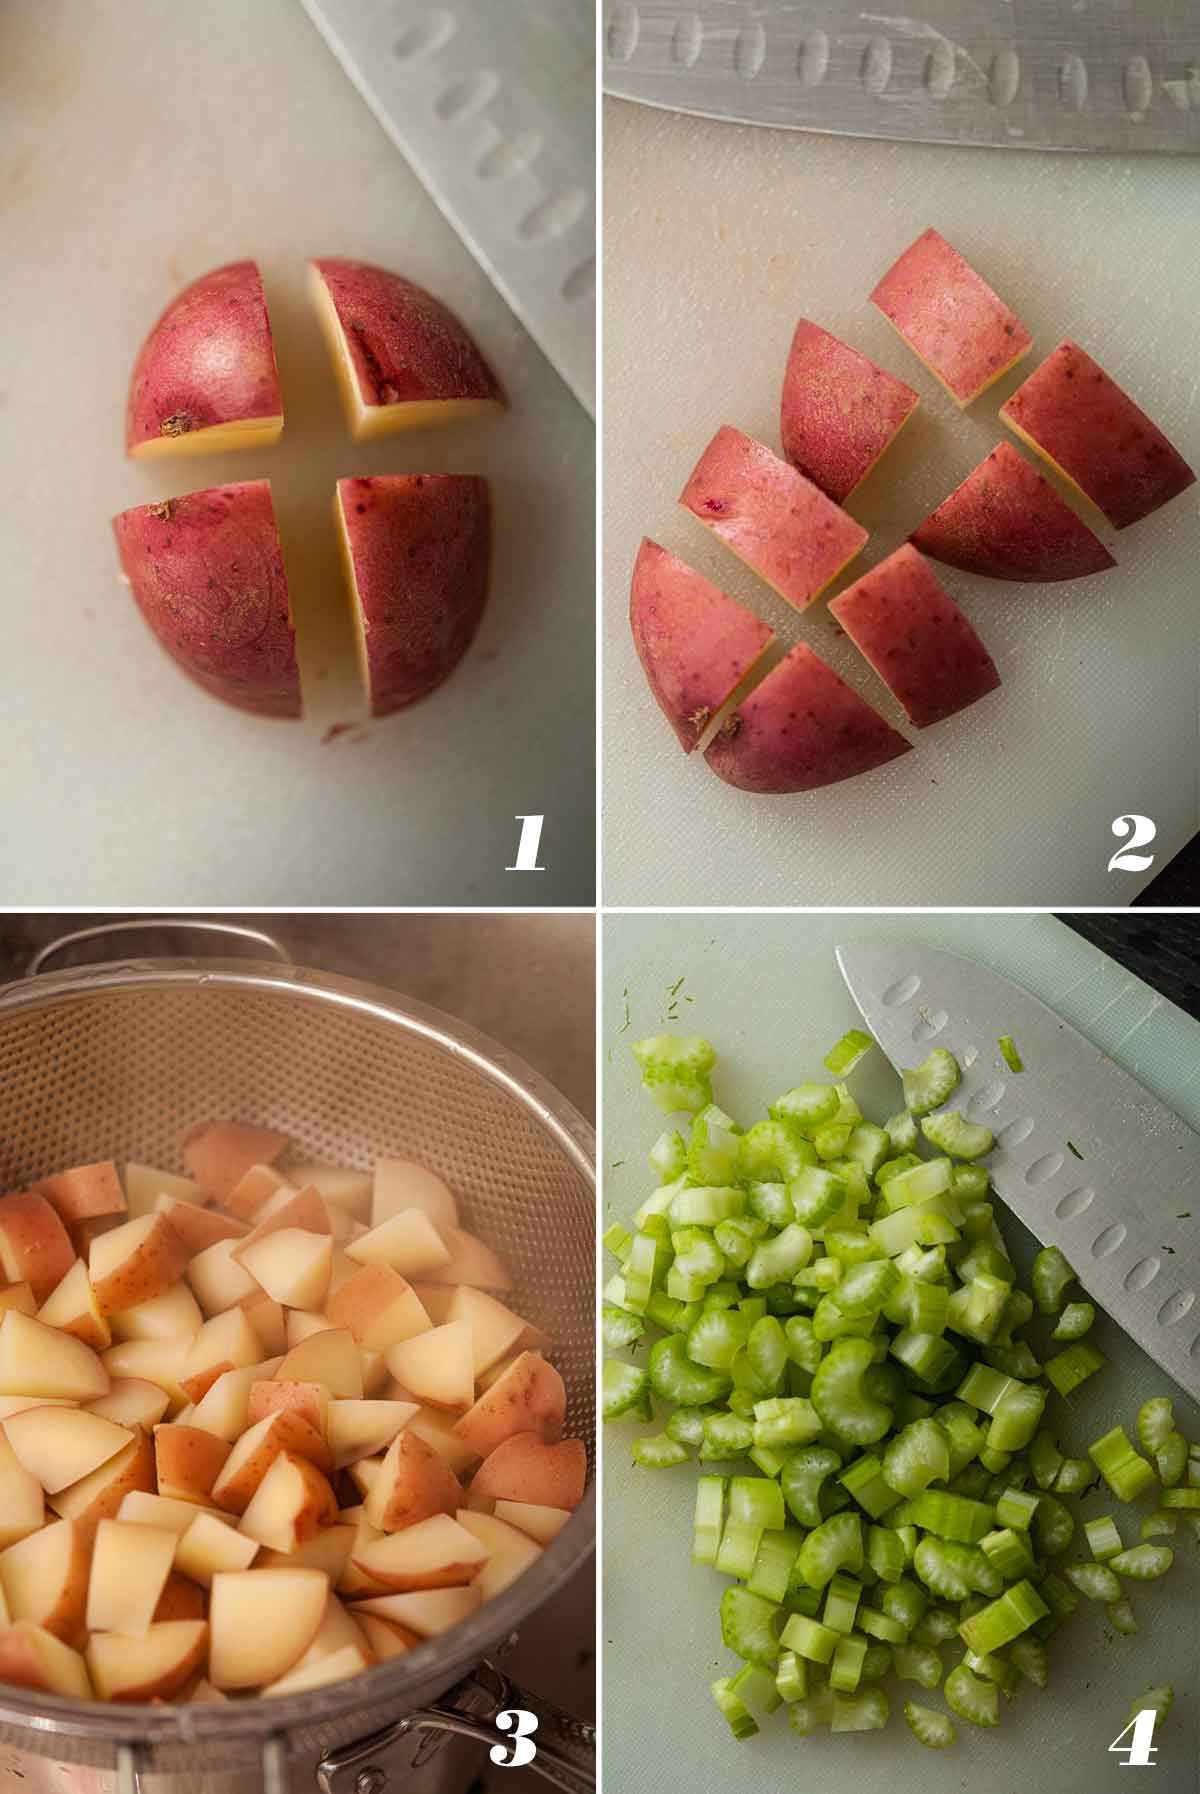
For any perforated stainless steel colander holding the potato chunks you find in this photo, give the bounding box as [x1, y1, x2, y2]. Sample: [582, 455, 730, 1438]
[0, 922, 596, 1794]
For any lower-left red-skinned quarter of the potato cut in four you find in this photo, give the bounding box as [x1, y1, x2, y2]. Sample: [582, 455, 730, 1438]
[113, 479, 301, 716]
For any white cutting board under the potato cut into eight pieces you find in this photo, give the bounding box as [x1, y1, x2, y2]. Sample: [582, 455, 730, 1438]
[603, 100, 1200, 908]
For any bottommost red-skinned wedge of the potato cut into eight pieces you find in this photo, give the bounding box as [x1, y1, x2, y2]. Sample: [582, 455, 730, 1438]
[705, 642, 909, 795]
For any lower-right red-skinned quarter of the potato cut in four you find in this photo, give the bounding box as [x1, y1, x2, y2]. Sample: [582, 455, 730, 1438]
[337, 474, 491, 716]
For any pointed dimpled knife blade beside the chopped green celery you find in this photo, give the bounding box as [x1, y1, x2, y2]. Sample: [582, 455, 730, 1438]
[838, 940, 1200, 1398]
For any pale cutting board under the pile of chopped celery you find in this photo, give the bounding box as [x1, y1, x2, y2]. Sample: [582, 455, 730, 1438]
[601, 915, 1200, 1794]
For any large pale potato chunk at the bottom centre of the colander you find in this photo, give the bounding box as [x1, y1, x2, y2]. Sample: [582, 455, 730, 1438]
[208, 1570, 328, 1688]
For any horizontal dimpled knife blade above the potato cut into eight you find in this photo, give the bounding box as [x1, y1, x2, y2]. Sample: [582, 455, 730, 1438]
[604, 0, 1200, 154]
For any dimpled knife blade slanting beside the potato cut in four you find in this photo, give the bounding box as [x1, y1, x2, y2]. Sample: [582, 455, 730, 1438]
[301, 0, 596, 413]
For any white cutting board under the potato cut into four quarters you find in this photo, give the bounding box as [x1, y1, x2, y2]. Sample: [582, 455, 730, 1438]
[0, 0, 594, 908]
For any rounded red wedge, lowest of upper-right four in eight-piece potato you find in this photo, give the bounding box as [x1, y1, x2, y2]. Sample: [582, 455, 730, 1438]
[907, 443, 1116, 581]
